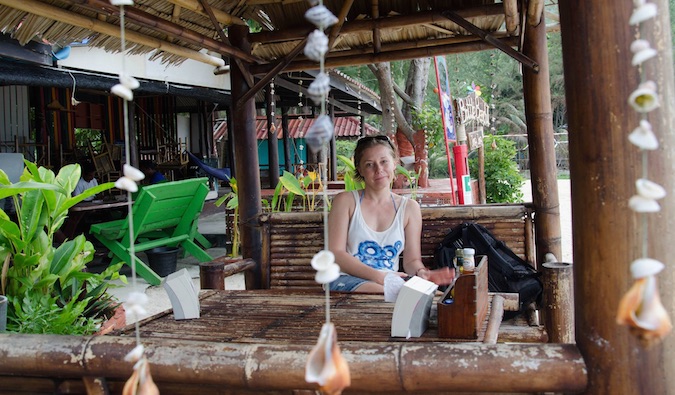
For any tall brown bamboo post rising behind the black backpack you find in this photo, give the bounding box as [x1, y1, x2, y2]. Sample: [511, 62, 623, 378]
[523, 4, 562, 264]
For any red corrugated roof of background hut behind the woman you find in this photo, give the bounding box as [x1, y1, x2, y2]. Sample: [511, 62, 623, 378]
[213, 116, 380, 140]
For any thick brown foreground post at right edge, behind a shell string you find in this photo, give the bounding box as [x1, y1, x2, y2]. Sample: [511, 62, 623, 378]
[559, 0, 675, 394]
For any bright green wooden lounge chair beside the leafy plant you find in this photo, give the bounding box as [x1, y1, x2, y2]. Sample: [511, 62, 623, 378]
[90, 178, 213, 285]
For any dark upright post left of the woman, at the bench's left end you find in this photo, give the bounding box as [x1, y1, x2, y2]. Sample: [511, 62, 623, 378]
[228, 26, 262, 289]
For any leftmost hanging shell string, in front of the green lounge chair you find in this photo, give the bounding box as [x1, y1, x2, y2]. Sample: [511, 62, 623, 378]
[110, 0, 159, 395]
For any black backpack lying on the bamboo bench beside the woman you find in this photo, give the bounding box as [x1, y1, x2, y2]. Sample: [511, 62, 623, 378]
[434, 222, 543, 318]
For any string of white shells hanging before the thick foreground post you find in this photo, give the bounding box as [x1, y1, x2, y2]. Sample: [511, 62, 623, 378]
[616, 0, 673, 347]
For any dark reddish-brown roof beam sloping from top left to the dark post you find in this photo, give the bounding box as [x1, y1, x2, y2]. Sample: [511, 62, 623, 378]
[69, 0, 262, 63]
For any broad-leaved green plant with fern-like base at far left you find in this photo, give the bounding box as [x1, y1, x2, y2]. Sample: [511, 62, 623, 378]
[0, 161, 124, 334]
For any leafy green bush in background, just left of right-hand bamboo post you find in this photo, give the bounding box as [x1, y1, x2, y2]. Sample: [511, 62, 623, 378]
[469, 135, 525, 203]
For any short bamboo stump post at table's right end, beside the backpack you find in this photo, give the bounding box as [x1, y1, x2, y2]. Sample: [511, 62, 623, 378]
[542, 262, 574, 343]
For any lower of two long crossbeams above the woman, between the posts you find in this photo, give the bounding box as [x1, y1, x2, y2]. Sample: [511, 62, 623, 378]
[250, 37, 518, 74]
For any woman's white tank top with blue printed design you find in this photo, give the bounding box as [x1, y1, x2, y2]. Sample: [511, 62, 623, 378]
[347, 191, 408, 271]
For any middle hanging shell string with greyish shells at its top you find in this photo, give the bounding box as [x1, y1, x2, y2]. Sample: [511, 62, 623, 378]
[304, 0, 351, 394]
